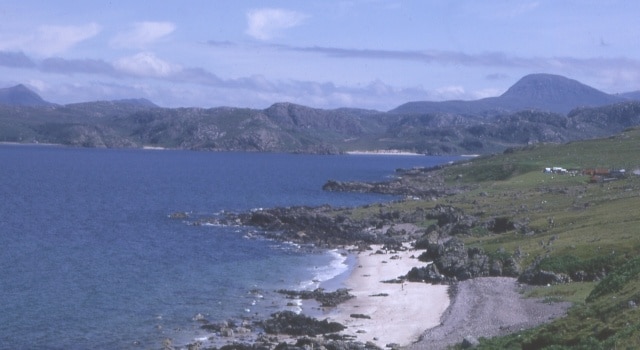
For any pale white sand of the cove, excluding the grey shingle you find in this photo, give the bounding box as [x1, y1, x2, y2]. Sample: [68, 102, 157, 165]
[328, 246, 449, 347]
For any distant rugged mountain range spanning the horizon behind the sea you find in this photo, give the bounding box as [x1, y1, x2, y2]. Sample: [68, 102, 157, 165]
[0, 74, 640, 155]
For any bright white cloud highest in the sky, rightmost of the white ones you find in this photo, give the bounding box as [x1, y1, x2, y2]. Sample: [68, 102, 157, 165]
[246, 8, 307, 40]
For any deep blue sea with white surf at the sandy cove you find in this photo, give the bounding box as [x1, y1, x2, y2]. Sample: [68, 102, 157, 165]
[0, 145, 458, 349]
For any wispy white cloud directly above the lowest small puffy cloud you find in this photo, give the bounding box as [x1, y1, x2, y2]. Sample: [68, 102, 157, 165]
[111, 22, 176, 48]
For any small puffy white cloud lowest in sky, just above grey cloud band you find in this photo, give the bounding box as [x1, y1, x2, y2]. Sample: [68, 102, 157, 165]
[113, 52, 182, 77]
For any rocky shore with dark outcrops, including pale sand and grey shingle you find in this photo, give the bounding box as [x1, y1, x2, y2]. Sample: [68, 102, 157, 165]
[171, 165, 576, 350]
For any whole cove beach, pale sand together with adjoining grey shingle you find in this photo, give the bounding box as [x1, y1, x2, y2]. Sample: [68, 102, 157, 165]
[328, 246, 570, 350]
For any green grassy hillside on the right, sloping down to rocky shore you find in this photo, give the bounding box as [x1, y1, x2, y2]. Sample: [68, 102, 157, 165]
[342, 129, 640, 349]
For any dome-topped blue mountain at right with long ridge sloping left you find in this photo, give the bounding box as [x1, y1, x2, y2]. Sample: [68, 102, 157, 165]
[390, 74, 626, 115]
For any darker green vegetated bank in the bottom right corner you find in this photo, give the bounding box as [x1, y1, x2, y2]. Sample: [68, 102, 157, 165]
[478, 258, 640, 349]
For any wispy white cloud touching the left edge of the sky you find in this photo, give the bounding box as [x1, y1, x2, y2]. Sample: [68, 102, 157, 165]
[0, 23, 101, 56]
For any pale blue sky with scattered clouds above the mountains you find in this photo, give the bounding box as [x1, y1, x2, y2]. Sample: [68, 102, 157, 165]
[0, 0, 640, 111]
